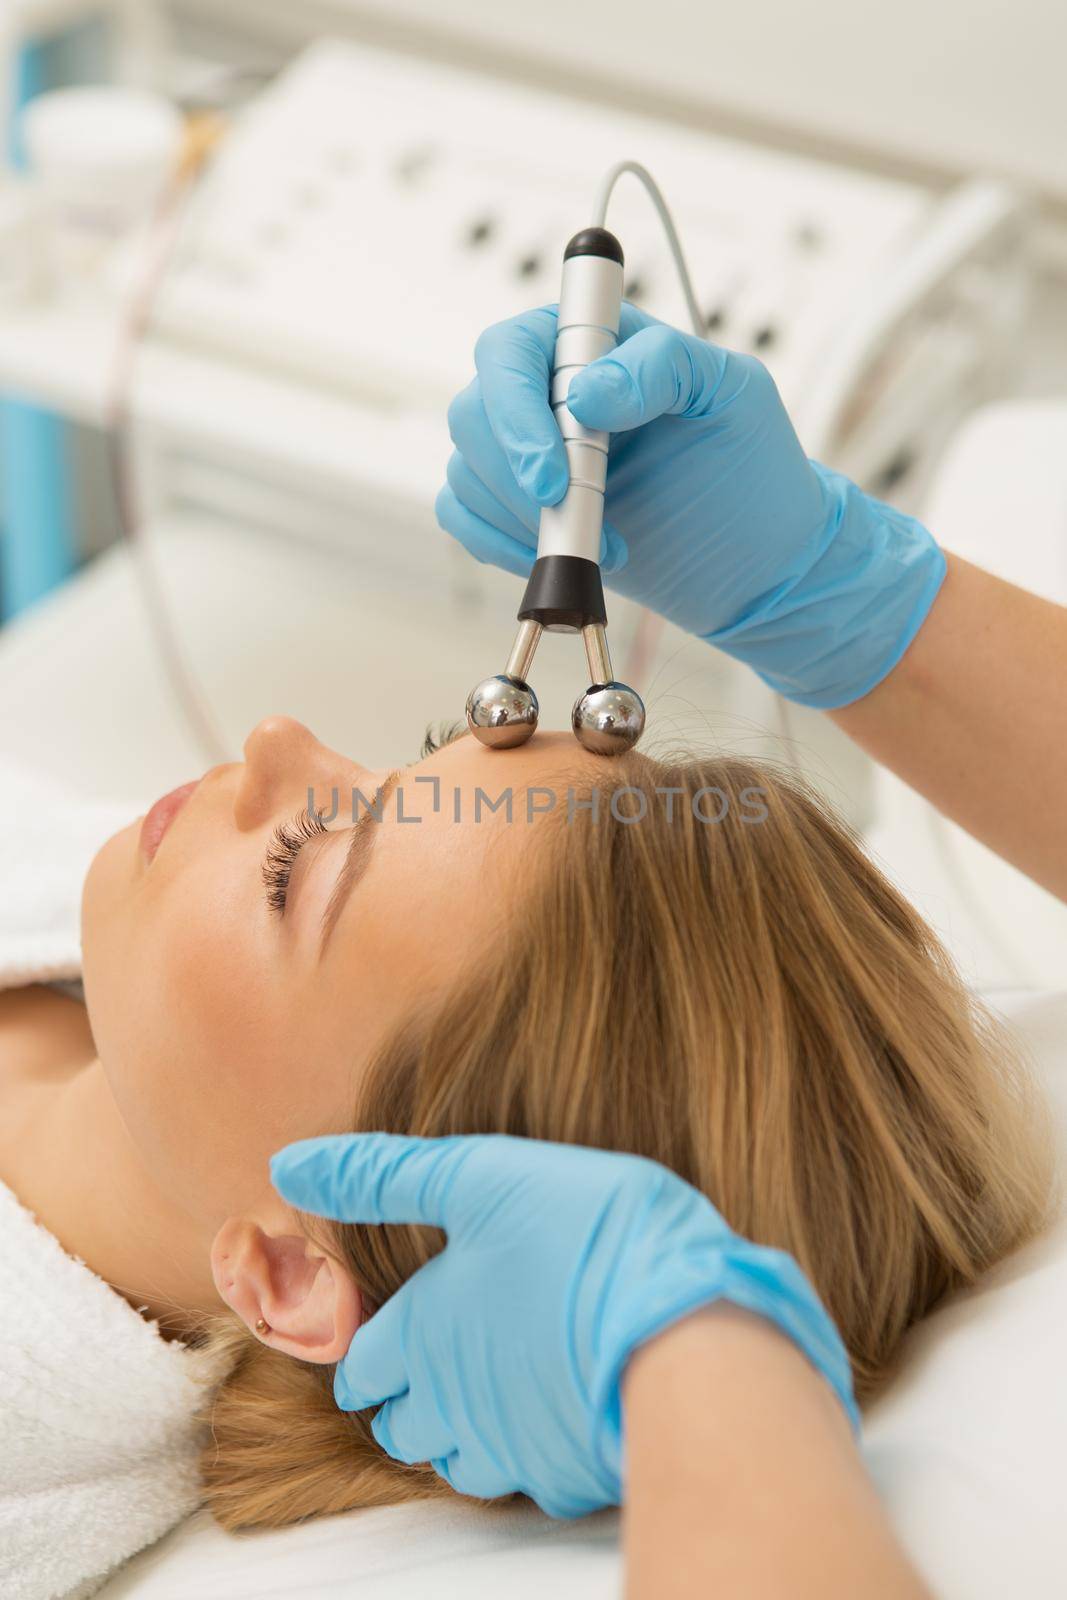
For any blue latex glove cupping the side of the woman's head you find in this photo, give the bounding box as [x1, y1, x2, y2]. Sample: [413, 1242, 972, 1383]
[270, 1133, 856, 1517]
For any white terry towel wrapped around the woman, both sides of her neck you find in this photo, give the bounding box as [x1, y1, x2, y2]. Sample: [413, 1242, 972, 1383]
[0, 765, 231, 1600]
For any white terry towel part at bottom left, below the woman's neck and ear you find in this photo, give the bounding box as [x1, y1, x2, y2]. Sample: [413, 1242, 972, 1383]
[0, 1184, 231, 1600]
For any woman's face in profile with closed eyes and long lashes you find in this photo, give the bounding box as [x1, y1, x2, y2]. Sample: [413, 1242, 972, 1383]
[82, 717, 608, 1227]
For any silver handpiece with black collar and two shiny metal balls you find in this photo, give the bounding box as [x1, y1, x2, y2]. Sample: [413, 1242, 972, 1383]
[467, 227, 645, 755]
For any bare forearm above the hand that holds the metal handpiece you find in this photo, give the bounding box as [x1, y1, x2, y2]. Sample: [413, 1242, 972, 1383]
[830, 557, 1067, 899]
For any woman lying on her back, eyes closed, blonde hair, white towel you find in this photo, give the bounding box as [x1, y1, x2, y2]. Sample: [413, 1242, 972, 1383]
[0, 717, 1049, 1600]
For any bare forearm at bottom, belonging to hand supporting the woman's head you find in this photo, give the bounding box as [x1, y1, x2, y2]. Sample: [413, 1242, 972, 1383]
[624, 1306, 929, 1600]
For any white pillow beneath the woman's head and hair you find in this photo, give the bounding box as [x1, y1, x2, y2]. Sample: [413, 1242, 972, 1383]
[101, 994, 1067, 1600]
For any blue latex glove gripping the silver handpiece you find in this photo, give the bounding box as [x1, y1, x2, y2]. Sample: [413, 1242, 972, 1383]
[437, 304, 945, 709]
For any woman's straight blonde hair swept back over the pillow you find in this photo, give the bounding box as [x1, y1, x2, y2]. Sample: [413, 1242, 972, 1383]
[202, 755, 1051, 1528]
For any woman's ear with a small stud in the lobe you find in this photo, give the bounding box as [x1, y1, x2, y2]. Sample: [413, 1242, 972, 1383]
[211, 1216, 363, 1363]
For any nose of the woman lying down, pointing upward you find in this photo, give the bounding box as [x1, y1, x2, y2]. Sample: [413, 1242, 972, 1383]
[234, 717, 362, 830]
